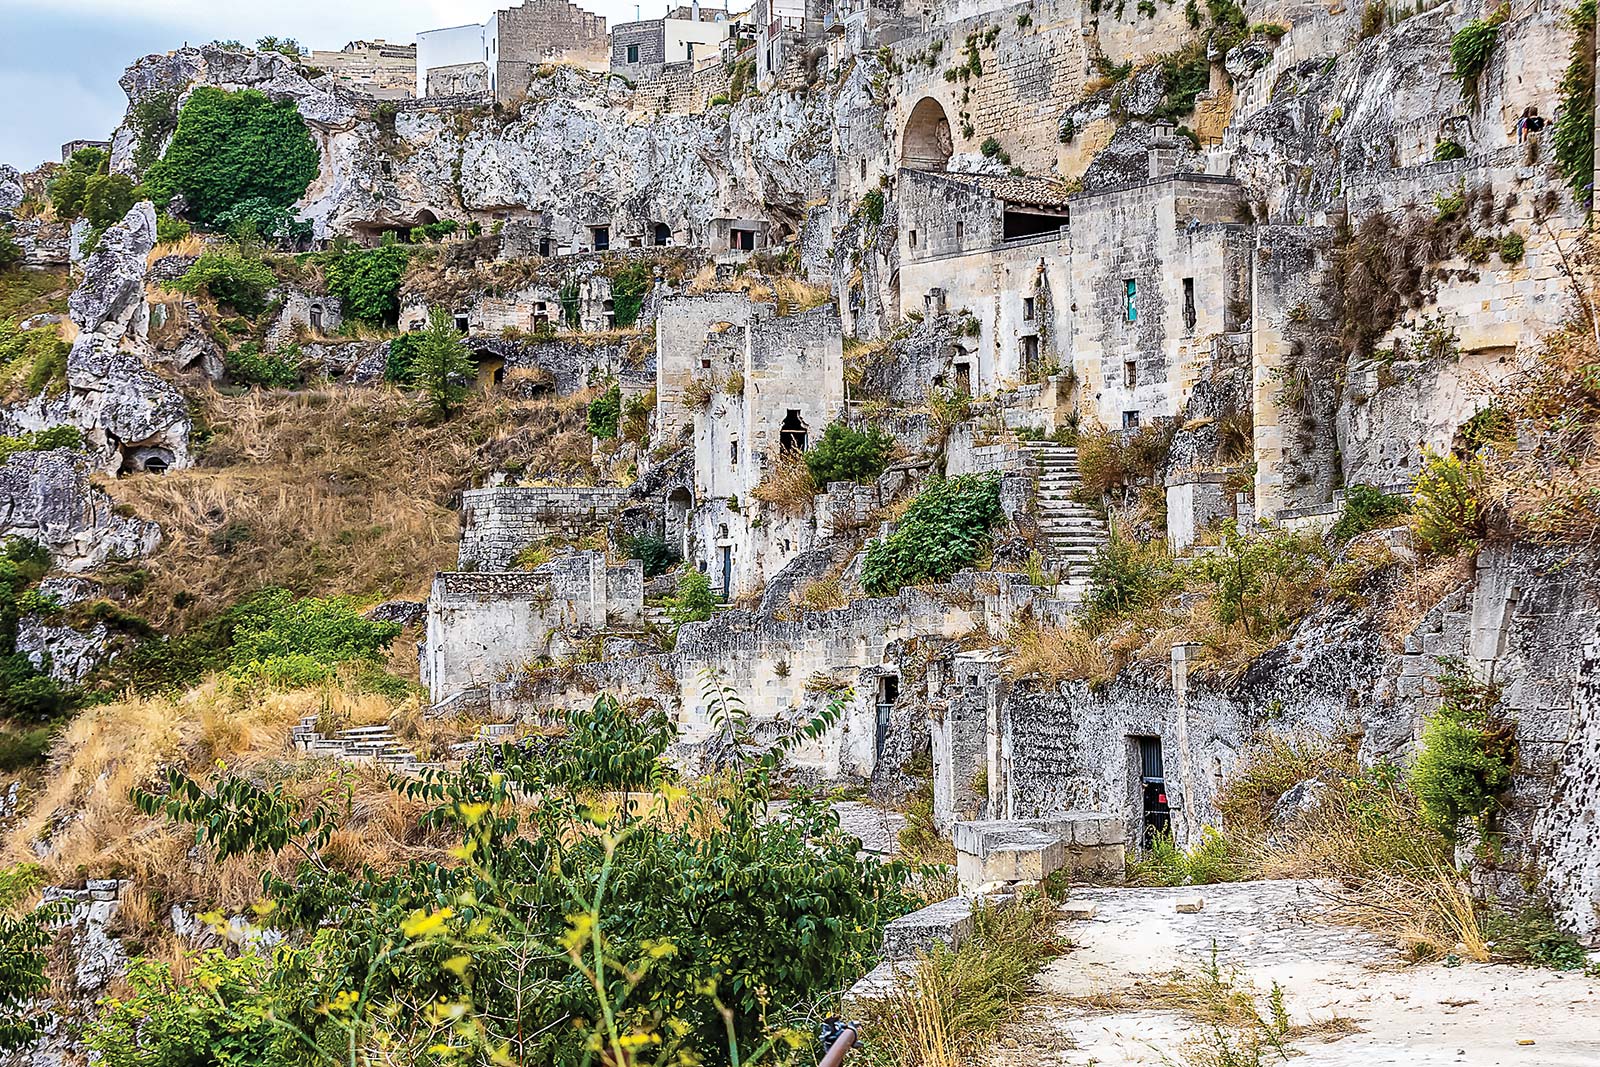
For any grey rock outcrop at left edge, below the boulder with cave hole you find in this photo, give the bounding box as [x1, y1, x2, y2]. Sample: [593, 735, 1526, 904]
[0, 448, 162, 571]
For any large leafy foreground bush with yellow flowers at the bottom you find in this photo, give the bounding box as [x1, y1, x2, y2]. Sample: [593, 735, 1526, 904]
[116, 697, 915, 1067]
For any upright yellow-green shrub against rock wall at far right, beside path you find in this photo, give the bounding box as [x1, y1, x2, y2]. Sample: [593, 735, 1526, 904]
[1410, 659, 1517, 841]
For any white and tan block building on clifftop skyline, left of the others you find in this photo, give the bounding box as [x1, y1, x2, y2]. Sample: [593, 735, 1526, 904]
[416, 0, 610, 104]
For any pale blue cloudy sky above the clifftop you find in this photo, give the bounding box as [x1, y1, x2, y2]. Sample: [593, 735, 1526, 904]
[0, 0, 667, 171]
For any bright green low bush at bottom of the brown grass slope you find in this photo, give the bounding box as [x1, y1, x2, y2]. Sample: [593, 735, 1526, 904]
[227, 589, 402, 686]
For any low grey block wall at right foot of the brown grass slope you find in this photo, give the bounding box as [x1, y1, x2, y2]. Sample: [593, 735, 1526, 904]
[456, 486, 629, 571]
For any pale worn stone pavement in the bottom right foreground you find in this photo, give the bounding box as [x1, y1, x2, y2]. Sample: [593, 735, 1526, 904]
[990, 881, 1600, 1067]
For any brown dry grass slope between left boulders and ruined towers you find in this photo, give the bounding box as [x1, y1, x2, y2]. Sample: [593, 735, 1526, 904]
[109, 387, 594, 630]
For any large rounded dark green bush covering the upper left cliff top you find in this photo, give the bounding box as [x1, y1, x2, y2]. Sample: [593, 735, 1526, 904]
[144, 85, 320, 224]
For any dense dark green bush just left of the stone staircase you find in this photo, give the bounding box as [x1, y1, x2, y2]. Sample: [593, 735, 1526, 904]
[861, 474, 1005, 597]
